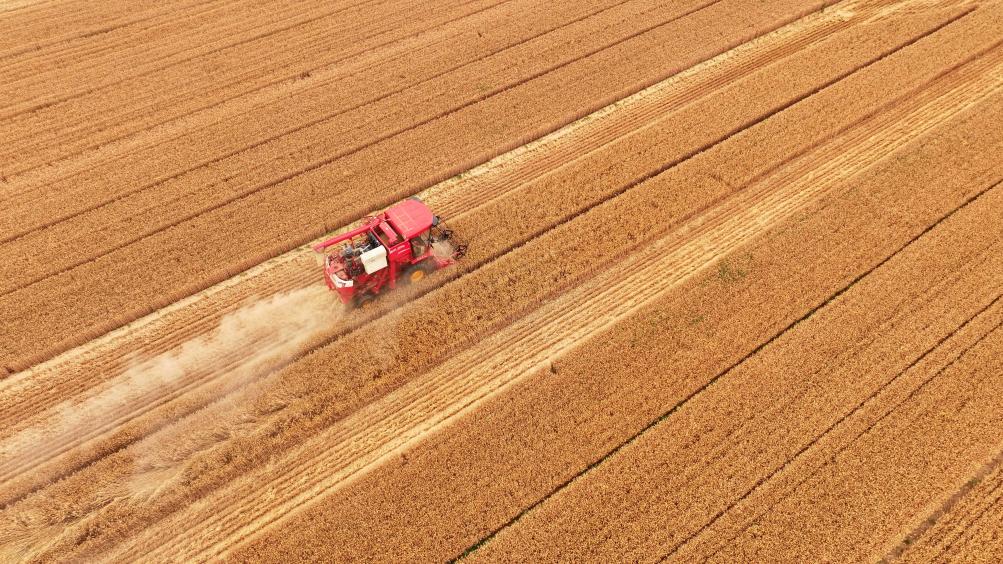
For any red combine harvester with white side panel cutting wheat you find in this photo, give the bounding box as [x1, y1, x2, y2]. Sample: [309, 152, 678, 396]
[313, 198, 466, 307]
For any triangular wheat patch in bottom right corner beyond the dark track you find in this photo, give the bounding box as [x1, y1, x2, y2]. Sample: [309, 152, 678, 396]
[892, 453, 1003, 563]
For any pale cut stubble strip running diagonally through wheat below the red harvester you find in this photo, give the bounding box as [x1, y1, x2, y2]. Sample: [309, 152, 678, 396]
[109, 37, 994, 558]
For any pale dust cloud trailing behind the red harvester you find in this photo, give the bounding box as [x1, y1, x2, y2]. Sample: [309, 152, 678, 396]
[0, 286, 344, 483]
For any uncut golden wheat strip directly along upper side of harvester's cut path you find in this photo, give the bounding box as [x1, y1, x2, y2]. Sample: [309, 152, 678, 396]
[0, 0, 838, 368]
